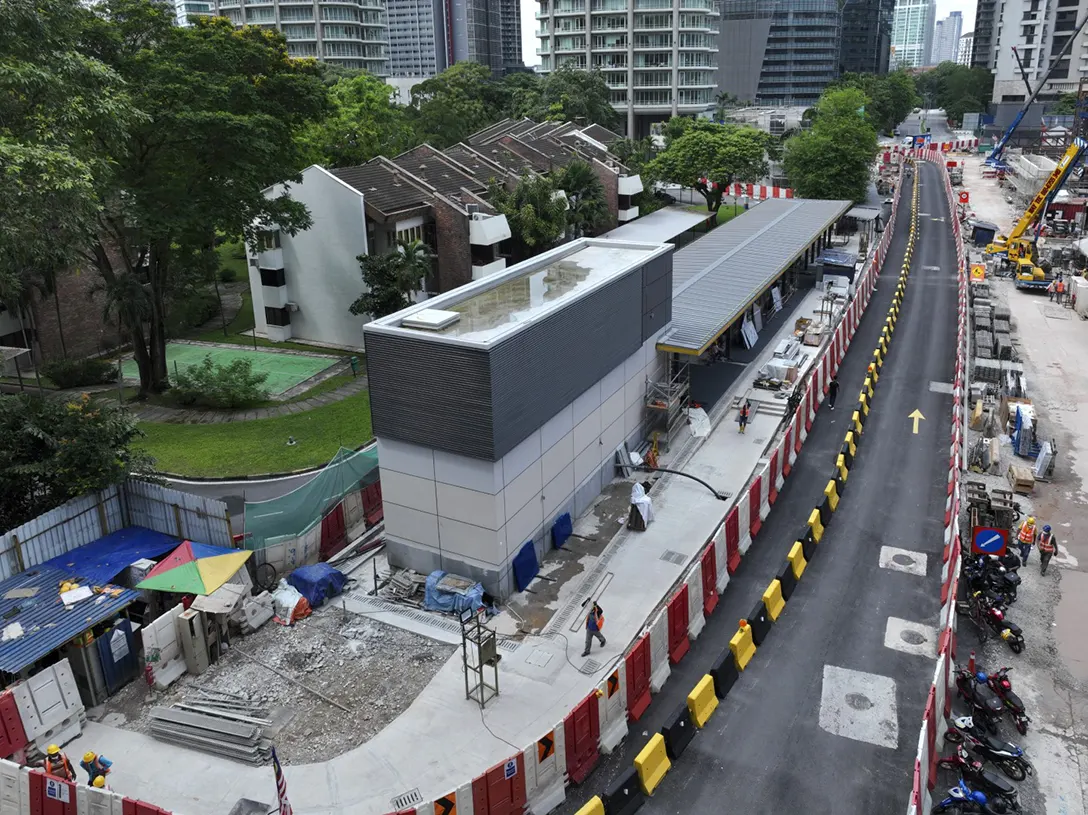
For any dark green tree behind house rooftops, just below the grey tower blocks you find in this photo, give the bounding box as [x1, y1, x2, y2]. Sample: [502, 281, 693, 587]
[411, 62, 506, 150]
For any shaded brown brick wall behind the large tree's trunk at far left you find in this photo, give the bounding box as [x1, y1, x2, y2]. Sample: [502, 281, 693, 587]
[34, 267, 118, 362]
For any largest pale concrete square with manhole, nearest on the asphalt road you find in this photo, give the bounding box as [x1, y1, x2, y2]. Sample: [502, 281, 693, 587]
[819, 665, 899, 750]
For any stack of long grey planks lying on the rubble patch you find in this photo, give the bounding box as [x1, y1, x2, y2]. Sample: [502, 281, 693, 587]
[151, 691, 272, 764]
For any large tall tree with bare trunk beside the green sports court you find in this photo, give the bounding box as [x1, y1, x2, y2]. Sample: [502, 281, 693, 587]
[79, 0, 327, 393]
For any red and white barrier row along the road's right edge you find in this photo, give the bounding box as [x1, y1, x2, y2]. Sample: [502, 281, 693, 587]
[907, 151, 977, 815]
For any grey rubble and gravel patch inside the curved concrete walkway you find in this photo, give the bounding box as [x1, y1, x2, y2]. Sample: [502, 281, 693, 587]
[93, 607, 455, 764]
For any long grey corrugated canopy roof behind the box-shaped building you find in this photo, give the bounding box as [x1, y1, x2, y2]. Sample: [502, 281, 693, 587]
[657, 198, 851, 355]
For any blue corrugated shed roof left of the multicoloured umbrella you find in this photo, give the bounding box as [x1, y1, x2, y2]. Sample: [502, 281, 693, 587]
[0, 565, 138, 674]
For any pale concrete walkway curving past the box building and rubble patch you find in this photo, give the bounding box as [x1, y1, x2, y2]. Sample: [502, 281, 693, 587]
[57, 278, 857, 815]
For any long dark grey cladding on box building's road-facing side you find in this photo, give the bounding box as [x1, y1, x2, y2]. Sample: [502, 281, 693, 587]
[491, 268, 642, 459]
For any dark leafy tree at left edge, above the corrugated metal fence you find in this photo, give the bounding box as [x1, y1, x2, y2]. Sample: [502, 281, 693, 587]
[0, 394, 154, 530]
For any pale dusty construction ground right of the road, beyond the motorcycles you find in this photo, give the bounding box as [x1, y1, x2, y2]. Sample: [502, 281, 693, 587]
[961, 157, 1088, 815]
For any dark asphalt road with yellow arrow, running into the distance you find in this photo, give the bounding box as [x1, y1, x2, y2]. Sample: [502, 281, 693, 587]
[560, 165, 956, 815]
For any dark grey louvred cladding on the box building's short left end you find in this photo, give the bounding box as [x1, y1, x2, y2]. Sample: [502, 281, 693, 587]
[363, 330, 494, 460]
